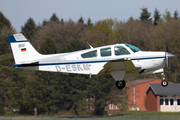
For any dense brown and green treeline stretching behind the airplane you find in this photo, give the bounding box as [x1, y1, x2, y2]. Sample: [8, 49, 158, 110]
[0, 8, 180, 115]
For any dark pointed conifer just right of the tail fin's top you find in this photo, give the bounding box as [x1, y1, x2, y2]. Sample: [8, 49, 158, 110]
[21, 17, 37, 40]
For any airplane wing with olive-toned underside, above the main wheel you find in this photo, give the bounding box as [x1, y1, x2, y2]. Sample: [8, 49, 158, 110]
[98, 58, 141, 75]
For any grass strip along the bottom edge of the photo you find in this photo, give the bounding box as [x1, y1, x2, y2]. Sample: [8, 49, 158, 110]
[0, 112, 180, 120]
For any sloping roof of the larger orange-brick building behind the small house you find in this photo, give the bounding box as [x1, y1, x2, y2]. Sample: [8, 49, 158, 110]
[127, 78, 160, 87]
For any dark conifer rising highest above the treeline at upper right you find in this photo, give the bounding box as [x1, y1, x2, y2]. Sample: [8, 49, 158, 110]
[140, 8, 152, 22]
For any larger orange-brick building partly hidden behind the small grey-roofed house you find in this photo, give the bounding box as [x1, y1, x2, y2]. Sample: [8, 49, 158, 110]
[127, 79, 162, 111]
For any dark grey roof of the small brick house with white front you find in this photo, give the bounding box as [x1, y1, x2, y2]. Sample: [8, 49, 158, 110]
[145, 83, 180, 95]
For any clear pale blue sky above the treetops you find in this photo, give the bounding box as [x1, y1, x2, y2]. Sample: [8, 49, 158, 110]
[0, 0, 180, 32]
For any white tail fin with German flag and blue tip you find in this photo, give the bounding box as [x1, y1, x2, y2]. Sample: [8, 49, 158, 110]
[8, 33, 42, 64]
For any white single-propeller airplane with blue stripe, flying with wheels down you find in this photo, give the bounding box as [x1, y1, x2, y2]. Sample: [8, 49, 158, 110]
[8, 33, 174, 89]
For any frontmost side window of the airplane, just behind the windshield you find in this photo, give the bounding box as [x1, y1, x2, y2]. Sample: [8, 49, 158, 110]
[114, 46, 130, 55]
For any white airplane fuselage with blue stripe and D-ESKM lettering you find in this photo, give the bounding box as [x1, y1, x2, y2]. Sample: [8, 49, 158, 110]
[14, 44, 166, 75]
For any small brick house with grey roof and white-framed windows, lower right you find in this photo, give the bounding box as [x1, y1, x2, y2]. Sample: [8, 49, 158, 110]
[146, 83, 180, 112]
